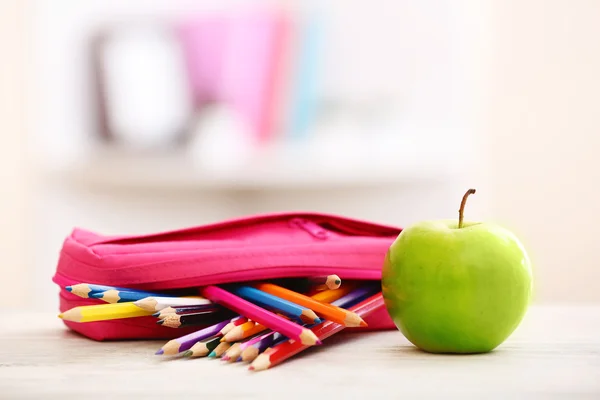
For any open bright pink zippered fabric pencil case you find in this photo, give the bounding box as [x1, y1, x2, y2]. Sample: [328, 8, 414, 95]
[53, 213, 401, 340]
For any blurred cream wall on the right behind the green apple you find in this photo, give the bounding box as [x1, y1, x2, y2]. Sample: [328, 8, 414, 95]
[482, 0, 600, 301]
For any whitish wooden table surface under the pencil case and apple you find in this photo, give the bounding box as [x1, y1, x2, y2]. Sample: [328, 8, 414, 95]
[0, 306, 600, 400]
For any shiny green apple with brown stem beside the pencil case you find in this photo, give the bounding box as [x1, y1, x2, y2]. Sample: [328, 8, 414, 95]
[381, 189, 532, 353]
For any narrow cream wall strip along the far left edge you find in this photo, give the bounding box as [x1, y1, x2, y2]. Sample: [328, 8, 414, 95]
[0, 1, 31, 306]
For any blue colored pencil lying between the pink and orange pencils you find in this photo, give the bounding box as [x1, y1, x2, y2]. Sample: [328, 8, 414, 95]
[231, 286, 322, 324]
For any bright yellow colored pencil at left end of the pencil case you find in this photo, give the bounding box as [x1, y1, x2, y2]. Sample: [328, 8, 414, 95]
[59, 303, 152, 322]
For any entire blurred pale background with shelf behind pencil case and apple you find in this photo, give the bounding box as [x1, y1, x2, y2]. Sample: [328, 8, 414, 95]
[0, 0, 600, 310]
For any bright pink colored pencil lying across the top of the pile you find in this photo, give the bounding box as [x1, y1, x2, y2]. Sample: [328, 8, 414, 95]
[200, 286, 321, 346]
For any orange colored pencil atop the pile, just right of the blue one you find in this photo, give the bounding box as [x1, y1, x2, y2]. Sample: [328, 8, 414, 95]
[255, 283, 367, 327]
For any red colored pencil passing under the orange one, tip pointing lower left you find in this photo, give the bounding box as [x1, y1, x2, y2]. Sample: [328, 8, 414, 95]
[249, 292, 385, 371]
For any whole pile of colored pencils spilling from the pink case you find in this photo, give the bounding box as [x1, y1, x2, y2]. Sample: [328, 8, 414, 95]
[59, 275, 385, 371]
